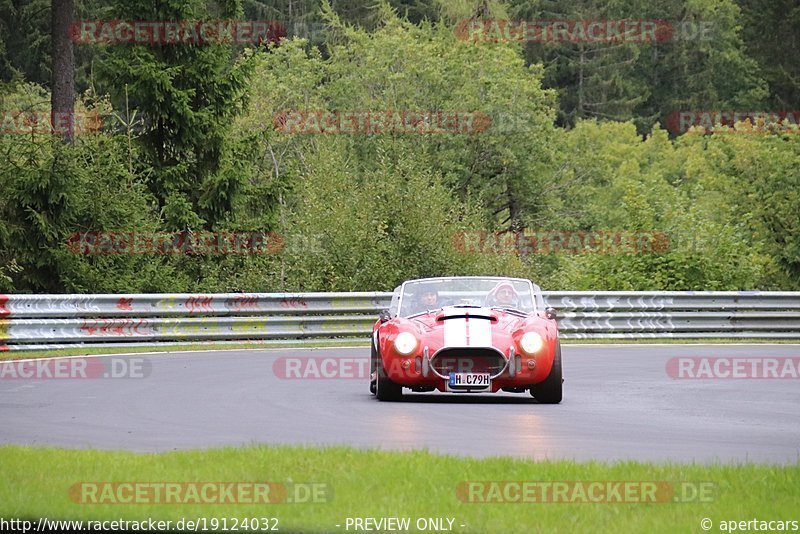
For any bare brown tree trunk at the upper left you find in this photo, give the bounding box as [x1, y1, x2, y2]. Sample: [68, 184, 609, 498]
[50, 0, 75, 144]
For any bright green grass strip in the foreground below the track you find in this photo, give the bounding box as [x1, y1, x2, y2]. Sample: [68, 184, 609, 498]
[0, 448, 800, 533]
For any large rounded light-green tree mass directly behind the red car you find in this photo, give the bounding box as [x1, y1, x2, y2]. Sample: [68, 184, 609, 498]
[240, 11, 556, 289]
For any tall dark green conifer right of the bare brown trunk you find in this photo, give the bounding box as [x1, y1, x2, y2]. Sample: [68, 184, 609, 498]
[100, 0, 250, 230]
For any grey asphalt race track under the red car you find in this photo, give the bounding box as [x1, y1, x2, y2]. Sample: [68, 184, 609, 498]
[0, 345, 800, 464]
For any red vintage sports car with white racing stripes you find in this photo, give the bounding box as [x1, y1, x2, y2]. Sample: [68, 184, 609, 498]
[370, 276, 563, 404]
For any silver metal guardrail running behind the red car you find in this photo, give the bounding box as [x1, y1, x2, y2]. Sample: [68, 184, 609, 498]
[0, 291, 800, 350]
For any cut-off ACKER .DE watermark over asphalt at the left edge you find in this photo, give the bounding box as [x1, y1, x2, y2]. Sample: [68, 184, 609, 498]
[0, 357, 152, 380]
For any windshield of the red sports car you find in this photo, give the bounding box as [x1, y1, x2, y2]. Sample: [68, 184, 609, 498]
[398, 277, 536, 317]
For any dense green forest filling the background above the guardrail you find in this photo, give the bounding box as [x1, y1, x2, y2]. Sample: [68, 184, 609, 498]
[0, 0, 800, 293]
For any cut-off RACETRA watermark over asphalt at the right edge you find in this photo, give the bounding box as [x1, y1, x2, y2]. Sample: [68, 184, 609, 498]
[666, 356, 800, 380]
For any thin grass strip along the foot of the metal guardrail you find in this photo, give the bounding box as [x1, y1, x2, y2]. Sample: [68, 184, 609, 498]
[0, 338, 800, 361]
